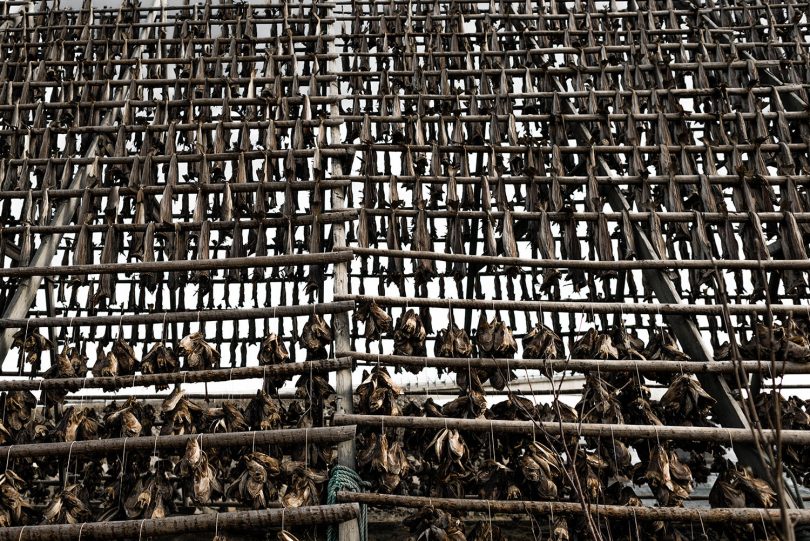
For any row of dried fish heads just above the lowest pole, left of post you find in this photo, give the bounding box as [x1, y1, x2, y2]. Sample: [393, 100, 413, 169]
[0, 446, 327, 526]
